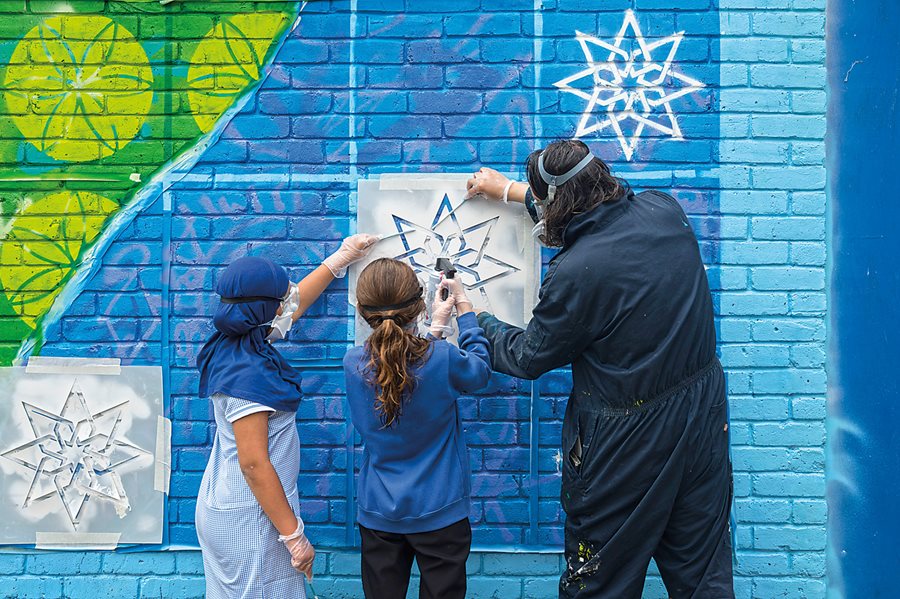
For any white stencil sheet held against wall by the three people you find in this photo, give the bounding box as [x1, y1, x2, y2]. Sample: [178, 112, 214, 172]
[350, 174, 540, 344]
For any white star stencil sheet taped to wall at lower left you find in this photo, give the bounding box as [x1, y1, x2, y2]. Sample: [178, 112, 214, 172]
[0, 359, 169, 546]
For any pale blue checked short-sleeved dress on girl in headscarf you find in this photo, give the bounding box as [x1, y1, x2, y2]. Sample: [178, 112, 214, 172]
[196, 394, 306, 599]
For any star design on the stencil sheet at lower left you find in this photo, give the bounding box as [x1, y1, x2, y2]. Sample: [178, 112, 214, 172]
[0, 379, 152, 530]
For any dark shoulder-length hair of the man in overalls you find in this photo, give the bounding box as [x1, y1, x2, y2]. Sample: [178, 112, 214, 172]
[526, 139, 624, 247]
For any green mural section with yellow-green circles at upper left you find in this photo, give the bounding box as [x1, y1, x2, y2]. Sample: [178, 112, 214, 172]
[0, 2, 297, 365]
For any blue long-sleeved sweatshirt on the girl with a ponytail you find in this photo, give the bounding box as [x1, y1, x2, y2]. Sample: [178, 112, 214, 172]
[344, 312, 491, 534]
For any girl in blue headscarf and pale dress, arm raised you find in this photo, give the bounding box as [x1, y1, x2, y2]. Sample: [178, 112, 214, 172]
[196, 235, 378, 599]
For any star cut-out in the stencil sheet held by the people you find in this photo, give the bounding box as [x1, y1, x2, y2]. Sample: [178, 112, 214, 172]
[391, 195, 521, 300]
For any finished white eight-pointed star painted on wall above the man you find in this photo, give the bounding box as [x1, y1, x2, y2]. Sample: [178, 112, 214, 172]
[553, 10, 706, 160]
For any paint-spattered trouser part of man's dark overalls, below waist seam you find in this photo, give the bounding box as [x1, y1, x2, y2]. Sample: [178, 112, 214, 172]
[560, 360, 734, 599]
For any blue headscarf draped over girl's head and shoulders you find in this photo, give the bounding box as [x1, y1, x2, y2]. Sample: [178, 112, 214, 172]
[197, 256, 302, 412]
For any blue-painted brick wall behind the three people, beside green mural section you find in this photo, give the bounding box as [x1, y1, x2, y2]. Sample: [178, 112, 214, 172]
[7, 0, 826, 599]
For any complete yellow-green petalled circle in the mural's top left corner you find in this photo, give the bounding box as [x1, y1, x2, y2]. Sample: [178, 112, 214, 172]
[4, 15, 153, 162]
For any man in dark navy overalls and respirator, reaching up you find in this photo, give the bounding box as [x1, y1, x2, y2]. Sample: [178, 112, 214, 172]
[469, 141, 734, 599]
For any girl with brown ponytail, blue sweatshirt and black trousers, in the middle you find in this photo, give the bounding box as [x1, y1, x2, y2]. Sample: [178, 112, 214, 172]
[344, 258, 491, 599]
